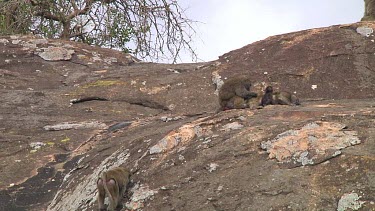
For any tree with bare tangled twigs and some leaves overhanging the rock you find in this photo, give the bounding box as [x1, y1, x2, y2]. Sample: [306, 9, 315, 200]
[0, 0, 195, 62]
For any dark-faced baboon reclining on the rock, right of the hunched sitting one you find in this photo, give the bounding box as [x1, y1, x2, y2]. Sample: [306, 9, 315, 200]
[260, 86, 300, 106]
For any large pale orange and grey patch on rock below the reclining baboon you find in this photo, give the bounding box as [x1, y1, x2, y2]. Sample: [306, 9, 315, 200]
[261, 121, 361, 168]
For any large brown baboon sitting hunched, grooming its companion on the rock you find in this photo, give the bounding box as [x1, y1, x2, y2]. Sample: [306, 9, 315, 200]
[219, 76, 258, 110]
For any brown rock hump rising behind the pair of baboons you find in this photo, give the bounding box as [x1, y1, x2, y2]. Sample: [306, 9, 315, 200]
[219, 22, 375, 99]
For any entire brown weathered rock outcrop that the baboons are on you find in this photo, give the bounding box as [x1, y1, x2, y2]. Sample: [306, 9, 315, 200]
[0, 22, 375, 210]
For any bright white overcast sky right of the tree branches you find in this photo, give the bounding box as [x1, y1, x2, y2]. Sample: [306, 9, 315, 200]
[178, 0, 364, 62]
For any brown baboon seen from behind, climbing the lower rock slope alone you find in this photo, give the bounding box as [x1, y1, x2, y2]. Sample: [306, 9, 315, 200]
[96, 167, 130, 211]
